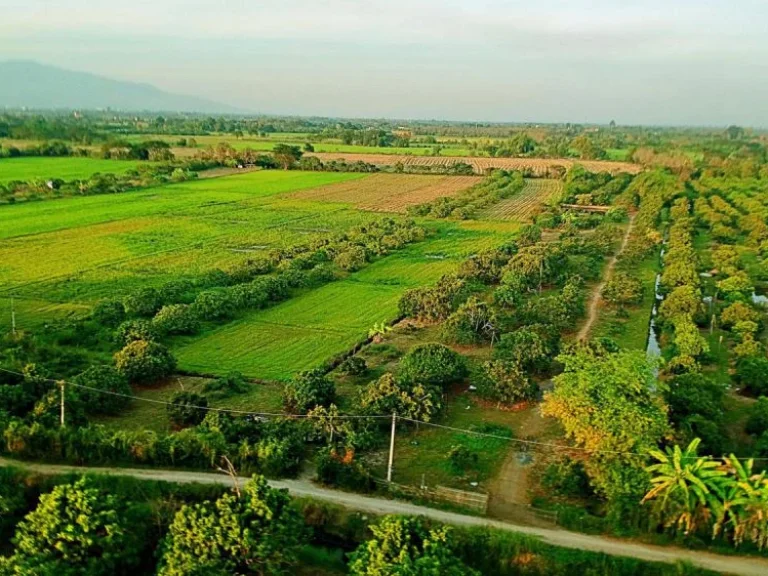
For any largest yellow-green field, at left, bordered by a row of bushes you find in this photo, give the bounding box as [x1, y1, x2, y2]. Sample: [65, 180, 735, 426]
[0, 172, 366, 304]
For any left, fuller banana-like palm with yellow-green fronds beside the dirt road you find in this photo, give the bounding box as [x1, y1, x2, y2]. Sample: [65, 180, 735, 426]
[643, 438, 727, 534]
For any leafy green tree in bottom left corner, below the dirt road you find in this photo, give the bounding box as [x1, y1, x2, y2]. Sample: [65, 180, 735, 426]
[3, 479, 146, 576]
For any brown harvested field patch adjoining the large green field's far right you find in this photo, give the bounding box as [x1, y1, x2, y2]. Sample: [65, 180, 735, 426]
[291, 174, 481, 212]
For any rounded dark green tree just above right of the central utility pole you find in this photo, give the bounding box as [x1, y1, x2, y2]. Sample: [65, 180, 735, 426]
[399, 343, 467, 387]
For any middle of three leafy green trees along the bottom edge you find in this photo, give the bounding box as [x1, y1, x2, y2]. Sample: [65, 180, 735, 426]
[158, 477, 307, 576]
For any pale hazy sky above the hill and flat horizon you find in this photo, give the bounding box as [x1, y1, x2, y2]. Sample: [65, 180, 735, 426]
[0, 0, 768, 127]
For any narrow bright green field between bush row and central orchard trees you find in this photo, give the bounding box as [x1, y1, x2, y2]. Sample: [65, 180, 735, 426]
[173, 218, 517, 380]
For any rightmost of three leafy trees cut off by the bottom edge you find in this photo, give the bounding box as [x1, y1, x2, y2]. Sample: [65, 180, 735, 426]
[349, 516, 479, 576]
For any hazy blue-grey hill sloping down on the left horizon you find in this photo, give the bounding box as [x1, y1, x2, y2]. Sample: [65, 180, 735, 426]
[0, 60, 242, 113]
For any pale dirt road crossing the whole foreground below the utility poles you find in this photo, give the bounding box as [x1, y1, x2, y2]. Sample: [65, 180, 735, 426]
[0, 458, 768, 576]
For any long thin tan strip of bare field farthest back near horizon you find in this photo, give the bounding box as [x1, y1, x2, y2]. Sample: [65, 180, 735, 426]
[306, 152, 642, 176]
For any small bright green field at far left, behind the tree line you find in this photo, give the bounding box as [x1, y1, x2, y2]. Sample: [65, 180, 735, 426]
[0, 157, 147, 184]
